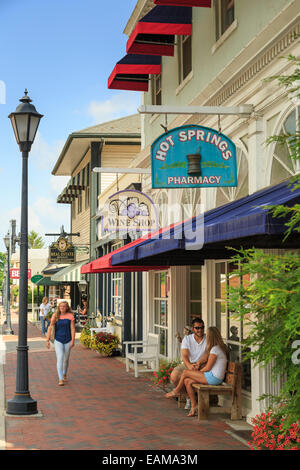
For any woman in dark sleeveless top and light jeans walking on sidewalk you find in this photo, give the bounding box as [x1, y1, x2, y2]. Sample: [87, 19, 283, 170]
[46, 301, 75, 385]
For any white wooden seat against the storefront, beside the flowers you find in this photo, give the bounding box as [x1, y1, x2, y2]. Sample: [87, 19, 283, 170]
[123, 333, 159, 377]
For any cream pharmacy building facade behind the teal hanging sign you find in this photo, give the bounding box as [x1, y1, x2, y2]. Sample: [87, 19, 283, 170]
[102, 0, 300, 420]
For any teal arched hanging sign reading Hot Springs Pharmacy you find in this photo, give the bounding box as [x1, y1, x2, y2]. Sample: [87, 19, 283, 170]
[151, 125, 237, 188]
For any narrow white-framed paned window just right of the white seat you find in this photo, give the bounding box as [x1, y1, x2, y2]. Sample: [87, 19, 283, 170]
[154, 271, 170, 357]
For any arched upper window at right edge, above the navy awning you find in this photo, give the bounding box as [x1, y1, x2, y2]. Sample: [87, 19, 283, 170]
[270, 106, 300, 184]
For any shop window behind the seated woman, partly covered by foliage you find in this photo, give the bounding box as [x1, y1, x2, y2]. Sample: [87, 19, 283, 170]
[215, 261, 251, 392]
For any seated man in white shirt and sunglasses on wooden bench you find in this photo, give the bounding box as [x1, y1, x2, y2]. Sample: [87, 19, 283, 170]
[170, 318, 208, 402]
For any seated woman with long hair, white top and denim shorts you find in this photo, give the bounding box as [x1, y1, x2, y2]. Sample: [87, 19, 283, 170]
[165, 326, 229, 416]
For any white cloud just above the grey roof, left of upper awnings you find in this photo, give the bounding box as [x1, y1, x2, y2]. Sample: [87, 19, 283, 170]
[88, 92, 140, 123]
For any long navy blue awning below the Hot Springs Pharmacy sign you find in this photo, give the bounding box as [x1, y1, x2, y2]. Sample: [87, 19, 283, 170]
[111, 181, 300, 265]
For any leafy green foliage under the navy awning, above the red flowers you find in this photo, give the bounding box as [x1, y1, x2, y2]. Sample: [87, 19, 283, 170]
[228, 249, 300, 424]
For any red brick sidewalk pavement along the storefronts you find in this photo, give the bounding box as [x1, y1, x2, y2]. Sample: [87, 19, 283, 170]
[4, 324, 247, 450]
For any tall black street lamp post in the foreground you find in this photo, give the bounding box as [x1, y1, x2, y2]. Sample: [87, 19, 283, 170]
[6, 90, 43, 415]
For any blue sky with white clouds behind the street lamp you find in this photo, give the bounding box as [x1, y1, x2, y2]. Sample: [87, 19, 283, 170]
[0, 0, 140, 251]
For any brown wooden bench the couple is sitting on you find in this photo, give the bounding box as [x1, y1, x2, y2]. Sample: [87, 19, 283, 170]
[178, 362, 242, 420]
